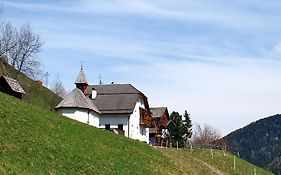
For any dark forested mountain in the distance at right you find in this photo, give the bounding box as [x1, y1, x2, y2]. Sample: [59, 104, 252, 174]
[224, 114, 281, 175]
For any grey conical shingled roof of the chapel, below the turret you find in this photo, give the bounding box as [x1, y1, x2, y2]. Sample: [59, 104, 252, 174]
[55, 88, 100, 114]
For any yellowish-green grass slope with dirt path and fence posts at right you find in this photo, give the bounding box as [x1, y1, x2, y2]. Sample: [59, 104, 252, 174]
[161, 149, 272, 175]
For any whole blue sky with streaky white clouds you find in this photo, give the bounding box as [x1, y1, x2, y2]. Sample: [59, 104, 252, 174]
[0, 0, 281, 136]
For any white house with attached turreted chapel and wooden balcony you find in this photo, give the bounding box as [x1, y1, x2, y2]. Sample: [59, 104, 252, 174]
[55, 68, 152, 143]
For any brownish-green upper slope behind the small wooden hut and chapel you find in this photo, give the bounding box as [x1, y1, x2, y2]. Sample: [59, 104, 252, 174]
[0, 60, 61, 110]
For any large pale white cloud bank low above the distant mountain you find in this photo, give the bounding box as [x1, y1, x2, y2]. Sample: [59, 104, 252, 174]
[110, 58, 281, 134]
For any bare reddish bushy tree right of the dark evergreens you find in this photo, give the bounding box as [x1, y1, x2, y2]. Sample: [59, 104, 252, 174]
[193, 124, 221, 145]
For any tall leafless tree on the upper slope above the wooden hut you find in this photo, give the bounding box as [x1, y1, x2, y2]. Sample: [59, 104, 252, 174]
[0, 23, 43, 78]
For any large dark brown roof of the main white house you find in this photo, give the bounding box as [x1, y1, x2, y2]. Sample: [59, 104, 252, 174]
[91, 84, 149, 114]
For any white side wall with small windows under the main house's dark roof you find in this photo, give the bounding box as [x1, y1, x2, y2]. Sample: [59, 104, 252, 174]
[99, 114, 129, 137]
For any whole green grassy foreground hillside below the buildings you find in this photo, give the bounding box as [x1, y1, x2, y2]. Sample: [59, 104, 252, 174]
[0, 93, 270, 175]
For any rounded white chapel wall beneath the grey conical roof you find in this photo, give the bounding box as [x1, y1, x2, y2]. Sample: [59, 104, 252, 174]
[58, 108, 99, 127]
